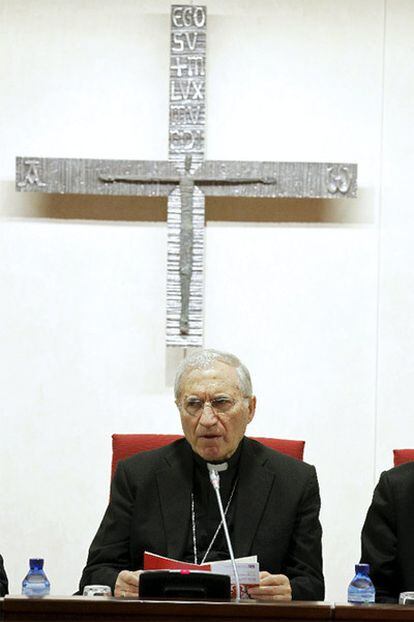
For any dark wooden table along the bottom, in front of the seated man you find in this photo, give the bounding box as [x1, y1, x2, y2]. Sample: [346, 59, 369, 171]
[0, 596, 414, 622]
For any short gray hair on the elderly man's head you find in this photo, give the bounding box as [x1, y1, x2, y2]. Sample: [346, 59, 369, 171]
[174, 350, 253, 399]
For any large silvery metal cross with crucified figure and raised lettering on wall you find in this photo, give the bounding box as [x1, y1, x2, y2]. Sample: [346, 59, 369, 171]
[16, 5, 357, 347]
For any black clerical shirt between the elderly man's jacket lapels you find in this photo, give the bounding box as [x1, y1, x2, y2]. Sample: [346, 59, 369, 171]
[183, 440, 243, 564]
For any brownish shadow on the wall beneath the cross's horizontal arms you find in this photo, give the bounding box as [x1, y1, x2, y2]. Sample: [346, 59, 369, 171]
[0, 181, 374, 224]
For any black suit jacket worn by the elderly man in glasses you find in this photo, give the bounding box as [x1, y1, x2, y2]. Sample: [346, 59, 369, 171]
[80, 438, 324, 600]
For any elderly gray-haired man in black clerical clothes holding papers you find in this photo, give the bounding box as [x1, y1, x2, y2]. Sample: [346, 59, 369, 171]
[80, 350, 324, 601]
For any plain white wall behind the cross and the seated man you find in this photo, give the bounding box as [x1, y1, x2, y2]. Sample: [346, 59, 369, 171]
[0, 0, 414, 601]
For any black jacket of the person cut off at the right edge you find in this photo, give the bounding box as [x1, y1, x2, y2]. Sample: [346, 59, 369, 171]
[361, 462, 414, 602]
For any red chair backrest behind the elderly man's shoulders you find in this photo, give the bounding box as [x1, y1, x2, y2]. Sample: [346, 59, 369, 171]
[111, 434, 305, 478]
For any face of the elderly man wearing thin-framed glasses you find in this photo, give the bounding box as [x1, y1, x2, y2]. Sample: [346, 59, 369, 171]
[177, 361, 256, 461]
